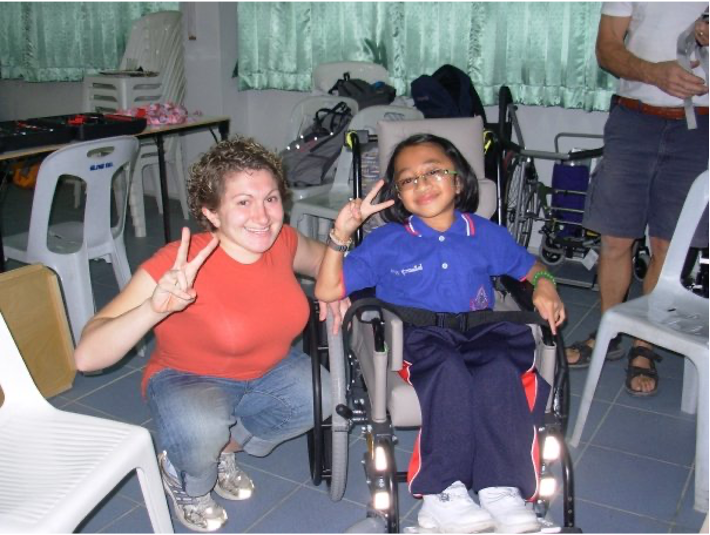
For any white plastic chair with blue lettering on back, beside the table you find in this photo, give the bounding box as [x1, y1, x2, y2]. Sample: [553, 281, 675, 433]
[4, 136, 138, 342]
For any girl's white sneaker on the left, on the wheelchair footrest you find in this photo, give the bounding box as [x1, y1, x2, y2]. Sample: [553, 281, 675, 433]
[419, 481, 494, 533]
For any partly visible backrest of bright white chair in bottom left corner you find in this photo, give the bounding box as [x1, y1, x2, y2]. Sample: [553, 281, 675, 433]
[0, 313, 47, 416]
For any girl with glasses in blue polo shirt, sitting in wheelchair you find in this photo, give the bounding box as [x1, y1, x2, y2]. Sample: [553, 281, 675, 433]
[315, 134, 565, 533]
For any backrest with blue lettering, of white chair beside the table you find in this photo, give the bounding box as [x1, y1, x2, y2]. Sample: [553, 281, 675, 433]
[27, 136, 140, 257]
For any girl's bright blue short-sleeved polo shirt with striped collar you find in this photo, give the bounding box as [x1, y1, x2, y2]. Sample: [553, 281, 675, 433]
[343, 211, 535, 313]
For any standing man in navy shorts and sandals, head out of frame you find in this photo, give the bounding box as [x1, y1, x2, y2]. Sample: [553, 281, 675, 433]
[567, 0, 709, 396]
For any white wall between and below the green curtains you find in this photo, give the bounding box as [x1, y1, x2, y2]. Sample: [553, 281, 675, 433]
[0, 1, 607, 249]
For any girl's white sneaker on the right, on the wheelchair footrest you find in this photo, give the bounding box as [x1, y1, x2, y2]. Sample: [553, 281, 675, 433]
[478, 487, 540, 533]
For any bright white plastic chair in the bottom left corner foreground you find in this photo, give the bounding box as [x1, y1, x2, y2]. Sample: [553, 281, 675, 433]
[0, 314, 173, 533]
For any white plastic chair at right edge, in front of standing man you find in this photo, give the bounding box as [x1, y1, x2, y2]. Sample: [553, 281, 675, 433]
[570, 171, 710, 512]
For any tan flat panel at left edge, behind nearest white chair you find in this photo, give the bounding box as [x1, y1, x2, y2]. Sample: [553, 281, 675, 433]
[0, 265, 76, 404]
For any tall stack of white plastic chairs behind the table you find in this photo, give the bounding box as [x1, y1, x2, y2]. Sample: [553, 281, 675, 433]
[84, 11, 189, 237]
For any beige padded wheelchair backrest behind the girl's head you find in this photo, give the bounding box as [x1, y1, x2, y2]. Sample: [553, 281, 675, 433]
[377, 117, 496, 217]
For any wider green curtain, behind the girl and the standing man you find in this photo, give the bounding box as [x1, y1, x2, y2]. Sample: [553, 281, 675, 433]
[237, 1, 616, 110]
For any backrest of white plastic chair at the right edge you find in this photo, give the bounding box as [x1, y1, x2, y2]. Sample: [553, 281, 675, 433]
[656, 170, 709, 291]
